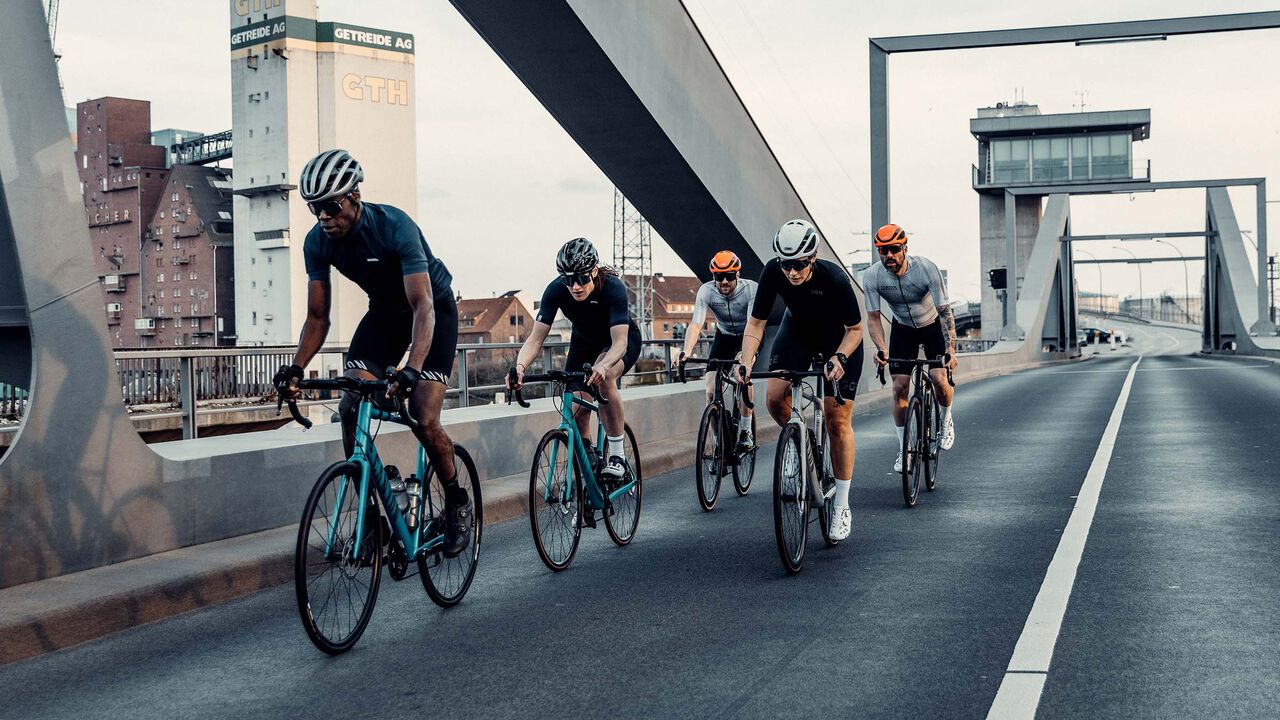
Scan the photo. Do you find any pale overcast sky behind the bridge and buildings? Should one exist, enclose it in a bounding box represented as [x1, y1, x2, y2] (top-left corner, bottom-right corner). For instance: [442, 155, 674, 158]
[58, 0, 1280, 300]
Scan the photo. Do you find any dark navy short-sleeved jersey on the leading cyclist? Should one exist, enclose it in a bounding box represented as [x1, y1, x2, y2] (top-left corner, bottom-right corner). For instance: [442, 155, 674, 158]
[302, 202, 453, 311]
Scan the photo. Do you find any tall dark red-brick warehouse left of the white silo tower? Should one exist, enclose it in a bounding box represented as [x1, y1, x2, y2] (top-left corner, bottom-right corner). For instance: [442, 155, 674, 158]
[76, 97, 236, 347]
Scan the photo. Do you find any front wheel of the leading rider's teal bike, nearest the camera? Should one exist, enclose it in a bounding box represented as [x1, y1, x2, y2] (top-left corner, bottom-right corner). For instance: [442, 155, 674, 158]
[293, 462, 384, 655]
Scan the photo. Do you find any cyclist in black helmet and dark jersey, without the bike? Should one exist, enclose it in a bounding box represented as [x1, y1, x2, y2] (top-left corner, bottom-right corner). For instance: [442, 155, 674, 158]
[506, 237, 640, 479]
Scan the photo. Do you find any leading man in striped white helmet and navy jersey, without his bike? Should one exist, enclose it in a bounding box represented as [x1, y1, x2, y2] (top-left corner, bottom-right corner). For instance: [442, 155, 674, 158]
[275, 150, 471, 557]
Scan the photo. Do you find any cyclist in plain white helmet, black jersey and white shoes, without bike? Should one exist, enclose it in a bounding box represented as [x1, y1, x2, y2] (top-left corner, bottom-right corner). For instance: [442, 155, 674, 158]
[742, 220, 863, 539]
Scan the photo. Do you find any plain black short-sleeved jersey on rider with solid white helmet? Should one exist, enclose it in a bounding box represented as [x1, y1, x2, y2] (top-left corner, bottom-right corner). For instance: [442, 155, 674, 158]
[751, 258, 863, 336]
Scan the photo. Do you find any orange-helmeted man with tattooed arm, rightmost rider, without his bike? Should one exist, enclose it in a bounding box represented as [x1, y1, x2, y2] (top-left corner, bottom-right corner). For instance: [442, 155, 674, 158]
[863, 224, 956, 473]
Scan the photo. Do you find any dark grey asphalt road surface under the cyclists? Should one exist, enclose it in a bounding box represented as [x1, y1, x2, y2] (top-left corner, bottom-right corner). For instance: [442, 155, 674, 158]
[0, 333, 1280, 719]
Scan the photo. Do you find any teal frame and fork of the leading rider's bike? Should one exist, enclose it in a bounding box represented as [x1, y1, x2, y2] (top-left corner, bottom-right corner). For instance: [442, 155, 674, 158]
[325, 397, 444, 560]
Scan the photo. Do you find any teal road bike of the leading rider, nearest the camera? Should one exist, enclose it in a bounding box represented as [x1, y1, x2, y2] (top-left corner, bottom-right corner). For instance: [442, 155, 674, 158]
[278, 368, 484, 655]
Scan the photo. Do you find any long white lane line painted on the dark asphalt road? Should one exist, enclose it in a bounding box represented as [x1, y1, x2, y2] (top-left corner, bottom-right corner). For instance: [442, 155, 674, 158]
[987, 356, 1142, 720]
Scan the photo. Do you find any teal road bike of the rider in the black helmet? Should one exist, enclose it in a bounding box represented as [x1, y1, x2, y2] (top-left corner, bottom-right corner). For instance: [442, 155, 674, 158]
[508, 368, 644, 571]
